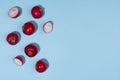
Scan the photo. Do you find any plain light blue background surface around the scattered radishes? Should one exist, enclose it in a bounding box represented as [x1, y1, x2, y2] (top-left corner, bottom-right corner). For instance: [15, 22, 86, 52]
[0, 0, 120, 80]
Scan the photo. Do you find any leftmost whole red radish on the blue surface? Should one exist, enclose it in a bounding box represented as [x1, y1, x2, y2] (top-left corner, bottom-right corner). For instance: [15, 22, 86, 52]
[7, 32, 19, 45]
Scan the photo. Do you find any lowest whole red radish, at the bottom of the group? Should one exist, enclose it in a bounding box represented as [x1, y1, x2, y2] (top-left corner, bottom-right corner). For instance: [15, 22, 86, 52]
[35, 60, 48, 73]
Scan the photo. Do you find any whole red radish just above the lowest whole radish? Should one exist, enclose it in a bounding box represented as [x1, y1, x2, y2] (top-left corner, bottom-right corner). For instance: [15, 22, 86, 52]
[24, 44, 38, 57]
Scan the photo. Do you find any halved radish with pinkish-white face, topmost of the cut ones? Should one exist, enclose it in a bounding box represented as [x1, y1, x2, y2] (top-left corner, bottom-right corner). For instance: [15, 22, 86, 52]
[8, 7, 20, 18]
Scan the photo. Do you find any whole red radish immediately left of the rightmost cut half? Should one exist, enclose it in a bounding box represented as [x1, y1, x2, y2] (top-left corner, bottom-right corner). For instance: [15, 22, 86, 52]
[22, 22, 35, 35]
